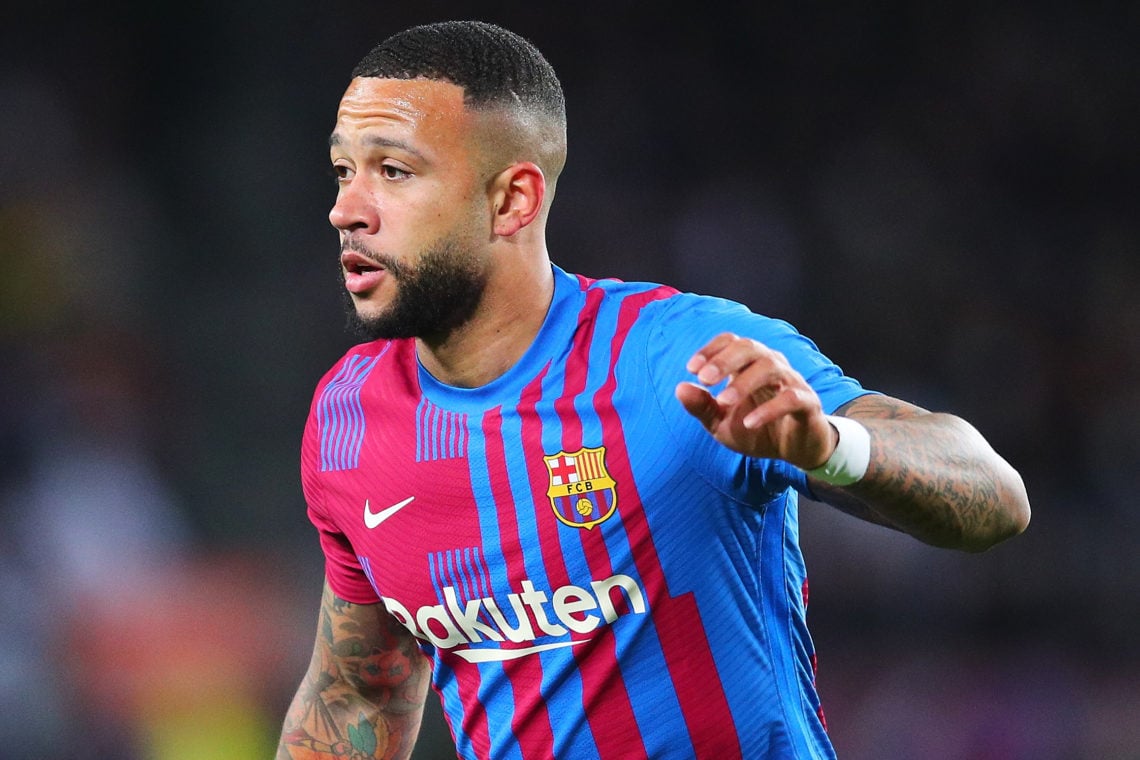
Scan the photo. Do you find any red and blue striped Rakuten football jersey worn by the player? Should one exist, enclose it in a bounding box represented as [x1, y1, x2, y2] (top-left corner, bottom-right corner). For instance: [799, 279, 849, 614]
[302, 267, 868, 760]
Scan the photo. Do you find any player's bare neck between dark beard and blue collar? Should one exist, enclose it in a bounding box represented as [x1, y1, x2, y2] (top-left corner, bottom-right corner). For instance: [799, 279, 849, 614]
[416, 256, 554, 387]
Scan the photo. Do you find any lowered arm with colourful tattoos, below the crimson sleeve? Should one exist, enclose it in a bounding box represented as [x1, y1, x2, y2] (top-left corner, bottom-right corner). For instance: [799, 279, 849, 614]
[277, 583, 430, 760]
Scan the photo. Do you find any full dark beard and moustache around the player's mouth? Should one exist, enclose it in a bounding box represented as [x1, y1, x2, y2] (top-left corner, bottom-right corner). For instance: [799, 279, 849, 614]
[341, 233, 487, 341]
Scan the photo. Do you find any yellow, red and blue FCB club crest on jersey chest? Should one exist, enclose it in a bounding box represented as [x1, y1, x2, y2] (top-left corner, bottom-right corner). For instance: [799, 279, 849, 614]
[543, 447, 618, 530]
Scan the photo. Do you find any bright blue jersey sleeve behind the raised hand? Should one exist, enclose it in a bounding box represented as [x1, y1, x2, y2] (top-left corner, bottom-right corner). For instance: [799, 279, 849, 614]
[646, 293, 874, 506]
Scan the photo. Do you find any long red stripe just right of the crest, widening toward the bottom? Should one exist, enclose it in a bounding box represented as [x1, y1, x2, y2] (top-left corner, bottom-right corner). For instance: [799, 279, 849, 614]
[594, 287, 741, 760]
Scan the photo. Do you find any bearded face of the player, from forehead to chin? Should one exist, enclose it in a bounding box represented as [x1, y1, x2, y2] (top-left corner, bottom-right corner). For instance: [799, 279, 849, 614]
[328, 77, 490, 338]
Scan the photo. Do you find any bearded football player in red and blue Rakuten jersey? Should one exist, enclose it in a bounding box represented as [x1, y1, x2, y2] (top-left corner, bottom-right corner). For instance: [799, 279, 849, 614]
[278, 22, 1029, 760]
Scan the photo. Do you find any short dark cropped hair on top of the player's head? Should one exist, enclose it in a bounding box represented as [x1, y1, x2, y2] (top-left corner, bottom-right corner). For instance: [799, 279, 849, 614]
[352, 21, 565, 125]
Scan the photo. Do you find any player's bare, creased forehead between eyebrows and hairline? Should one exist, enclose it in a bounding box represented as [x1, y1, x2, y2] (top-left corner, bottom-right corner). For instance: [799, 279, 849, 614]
[333, 76, 472, 147]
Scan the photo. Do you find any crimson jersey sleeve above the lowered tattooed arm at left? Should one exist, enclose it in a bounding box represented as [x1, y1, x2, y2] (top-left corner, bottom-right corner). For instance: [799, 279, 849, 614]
[301, 391, 380, 604]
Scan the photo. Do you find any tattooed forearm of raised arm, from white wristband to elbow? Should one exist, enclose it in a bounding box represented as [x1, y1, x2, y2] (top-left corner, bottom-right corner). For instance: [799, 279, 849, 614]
[812, 395, 1028, 550]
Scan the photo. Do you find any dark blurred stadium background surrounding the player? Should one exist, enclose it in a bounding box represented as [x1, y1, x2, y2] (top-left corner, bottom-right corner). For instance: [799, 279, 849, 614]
[0, 0, 1140, 760]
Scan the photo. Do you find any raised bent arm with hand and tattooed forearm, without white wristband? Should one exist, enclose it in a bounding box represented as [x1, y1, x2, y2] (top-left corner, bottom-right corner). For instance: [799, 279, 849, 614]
[677, 334, 1029, 551]
